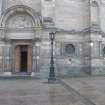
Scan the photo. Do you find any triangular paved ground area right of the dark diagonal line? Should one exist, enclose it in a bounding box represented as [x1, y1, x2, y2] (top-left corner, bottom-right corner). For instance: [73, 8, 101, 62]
[62, 77, 105, 105]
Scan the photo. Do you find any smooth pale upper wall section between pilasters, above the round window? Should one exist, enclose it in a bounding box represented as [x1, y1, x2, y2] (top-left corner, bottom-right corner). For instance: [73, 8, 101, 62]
[55, 0, 90, 30]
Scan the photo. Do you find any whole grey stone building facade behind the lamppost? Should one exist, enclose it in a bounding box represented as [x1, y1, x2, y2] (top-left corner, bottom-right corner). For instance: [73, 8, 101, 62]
[0, 0, 105, 77]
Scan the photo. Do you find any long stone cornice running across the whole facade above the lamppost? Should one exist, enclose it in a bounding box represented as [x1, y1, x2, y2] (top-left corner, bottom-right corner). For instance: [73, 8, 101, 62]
[0, 27, 105, 36]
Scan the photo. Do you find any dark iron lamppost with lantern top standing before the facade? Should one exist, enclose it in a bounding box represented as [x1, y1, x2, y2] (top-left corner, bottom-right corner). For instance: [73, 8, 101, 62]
[48, 32, 56, 83]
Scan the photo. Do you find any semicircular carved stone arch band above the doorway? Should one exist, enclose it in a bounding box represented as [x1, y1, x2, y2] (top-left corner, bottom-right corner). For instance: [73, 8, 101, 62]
[0, 5, 41, 27]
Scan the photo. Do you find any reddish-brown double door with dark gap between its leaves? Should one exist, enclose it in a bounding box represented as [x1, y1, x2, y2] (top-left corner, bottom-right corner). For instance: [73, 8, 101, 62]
[14, 45, 32, 73]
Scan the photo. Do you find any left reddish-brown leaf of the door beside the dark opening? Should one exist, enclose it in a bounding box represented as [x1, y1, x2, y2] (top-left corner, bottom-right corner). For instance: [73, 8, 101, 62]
[15, 46, 21, 72]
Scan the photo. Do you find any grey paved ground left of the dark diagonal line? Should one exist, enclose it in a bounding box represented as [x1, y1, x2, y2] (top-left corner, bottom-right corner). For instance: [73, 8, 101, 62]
[0, 79, 94, 105]
